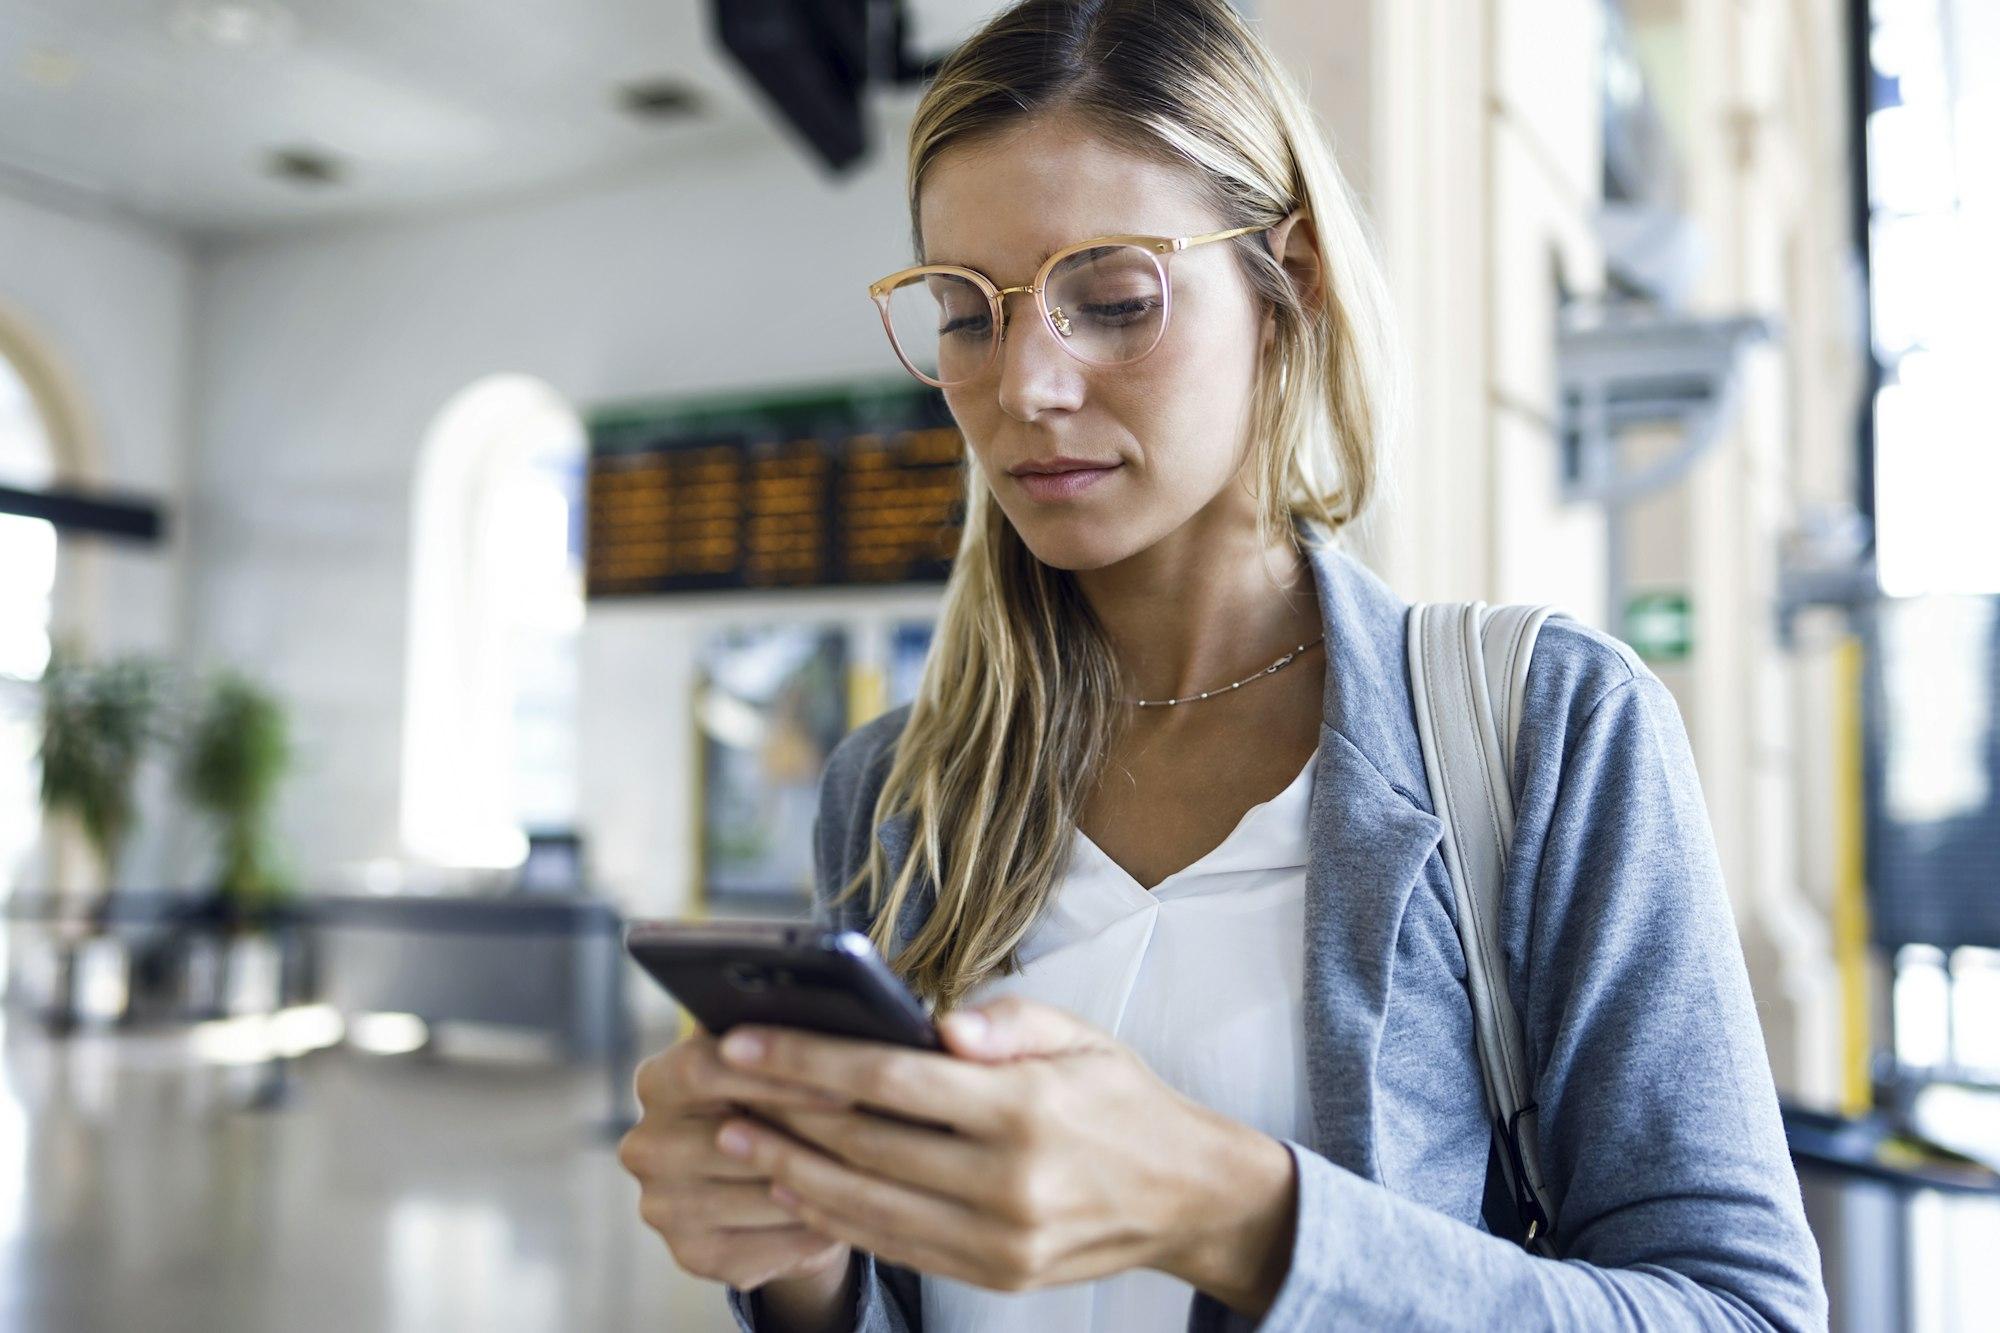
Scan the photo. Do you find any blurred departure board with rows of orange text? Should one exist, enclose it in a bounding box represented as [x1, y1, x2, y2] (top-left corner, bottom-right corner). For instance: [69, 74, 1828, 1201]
[584, 380, 964, 596]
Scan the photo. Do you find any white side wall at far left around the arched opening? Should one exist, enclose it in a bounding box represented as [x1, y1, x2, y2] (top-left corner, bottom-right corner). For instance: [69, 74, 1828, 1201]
[0, 176, 194, 885]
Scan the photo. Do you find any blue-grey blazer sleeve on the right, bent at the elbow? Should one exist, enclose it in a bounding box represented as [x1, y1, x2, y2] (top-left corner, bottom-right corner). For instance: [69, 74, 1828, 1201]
[1188, 671, 1826, 1333]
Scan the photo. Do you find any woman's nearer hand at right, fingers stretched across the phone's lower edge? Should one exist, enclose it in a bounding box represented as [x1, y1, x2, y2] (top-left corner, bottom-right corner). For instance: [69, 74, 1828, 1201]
[704, 997, 1296, 1311]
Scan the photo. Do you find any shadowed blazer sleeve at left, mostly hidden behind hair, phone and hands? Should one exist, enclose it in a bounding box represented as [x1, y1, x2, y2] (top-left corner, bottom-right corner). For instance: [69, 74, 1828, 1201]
[724, 707, 924, 1333]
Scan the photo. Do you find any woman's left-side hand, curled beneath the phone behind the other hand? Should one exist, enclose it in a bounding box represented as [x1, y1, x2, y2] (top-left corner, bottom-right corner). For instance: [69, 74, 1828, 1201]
[618, 1025, 848, 1291]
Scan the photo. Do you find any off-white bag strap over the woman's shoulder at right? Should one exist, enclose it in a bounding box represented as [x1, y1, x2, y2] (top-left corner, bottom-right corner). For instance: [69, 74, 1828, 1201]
[1410, 602, 1562, 1253]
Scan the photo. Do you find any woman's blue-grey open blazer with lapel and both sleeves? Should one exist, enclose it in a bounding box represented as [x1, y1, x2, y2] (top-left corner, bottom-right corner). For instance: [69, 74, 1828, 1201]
[728, 524, 1826, 1333]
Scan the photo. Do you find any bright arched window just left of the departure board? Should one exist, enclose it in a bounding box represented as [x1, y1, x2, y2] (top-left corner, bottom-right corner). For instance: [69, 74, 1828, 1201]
[402, 376, 584, 867]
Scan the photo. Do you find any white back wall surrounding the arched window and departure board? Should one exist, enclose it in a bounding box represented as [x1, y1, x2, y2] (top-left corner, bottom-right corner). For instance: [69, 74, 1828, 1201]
[192, 126, 936, 928]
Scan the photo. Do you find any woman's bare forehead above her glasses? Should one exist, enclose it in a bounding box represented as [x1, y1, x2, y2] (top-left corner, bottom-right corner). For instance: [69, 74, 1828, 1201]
[918, 120, 1222, 282]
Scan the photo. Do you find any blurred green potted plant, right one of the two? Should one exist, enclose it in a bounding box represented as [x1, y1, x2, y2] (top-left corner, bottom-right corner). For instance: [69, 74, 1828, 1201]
[178, 673, 292, 1011]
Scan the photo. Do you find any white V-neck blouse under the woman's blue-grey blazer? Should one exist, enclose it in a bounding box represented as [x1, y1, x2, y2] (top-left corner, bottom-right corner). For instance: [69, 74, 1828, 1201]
[920, 753, 1318, 1333]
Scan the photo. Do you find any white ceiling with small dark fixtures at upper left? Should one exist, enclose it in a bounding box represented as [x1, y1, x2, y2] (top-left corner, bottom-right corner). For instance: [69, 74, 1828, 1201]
[0, 0, 996, 236]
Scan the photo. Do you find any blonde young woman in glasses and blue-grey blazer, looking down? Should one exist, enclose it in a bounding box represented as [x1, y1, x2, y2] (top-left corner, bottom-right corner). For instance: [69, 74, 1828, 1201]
[620, 0, 1826, 1333]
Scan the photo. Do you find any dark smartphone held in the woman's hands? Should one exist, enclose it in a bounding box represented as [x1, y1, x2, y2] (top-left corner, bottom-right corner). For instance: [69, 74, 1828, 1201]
[624, 921, 944, 1051]
